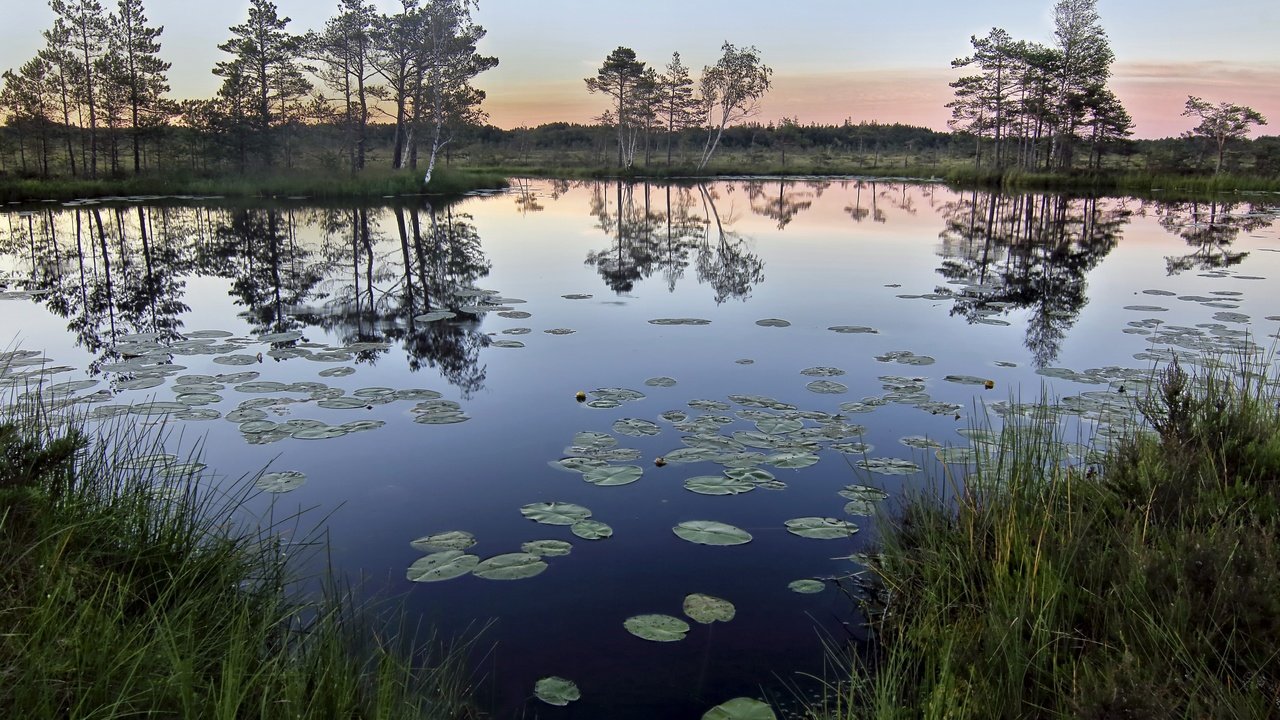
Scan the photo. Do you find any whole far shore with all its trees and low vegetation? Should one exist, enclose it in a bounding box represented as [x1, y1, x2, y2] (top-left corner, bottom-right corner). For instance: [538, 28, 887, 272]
[0, 0, 1280, 186]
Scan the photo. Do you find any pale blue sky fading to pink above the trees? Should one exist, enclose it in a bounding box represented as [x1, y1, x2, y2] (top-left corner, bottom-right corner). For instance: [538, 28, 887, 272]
[0, 0, 1280, 137]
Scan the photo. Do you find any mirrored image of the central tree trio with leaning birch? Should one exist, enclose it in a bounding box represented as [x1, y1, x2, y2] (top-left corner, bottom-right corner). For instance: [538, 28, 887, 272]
[586, 182, 764, 302]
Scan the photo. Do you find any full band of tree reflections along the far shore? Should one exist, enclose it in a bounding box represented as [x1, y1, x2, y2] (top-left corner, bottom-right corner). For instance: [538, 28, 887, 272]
[3, 184, 1274, 386]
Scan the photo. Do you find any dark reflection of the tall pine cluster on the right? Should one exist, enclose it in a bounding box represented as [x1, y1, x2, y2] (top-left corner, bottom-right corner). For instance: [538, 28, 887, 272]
[938, 191, 1130, 368]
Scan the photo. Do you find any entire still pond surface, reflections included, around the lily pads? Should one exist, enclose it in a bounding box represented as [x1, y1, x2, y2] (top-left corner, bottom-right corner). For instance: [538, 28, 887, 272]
[0, 181, 1280, 717]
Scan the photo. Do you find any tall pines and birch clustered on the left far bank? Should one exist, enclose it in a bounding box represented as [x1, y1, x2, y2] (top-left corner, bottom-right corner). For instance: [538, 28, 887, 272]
[0, 0, 498, 179]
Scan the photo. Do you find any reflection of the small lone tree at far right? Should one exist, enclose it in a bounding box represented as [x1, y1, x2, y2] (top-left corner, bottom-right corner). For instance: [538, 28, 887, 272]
[1155, 200, 1275, 275]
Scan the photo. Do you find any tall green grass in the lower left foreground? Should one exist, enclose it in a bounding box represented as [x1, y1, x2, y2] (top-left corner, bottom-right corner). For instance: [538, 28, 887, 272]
[0, 384, 472, 720]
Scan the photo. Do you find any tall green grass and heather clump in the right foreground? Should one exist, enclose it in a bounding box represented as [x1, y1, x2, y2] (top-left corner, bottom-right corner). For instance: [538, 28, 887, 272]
[810, 356, 1280, 720]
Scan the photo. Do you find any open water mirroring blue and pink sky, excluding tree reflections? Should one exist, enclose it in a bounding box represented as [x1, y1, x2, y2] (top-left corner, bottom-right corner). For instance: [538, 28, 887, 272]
[0, 181, 1280, 717]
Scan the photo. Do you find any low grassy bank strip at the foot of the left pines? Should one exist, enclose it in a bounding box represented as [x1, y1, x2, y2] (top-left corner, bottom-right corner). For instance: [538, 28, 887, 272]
[0, 168, 507, 202]
